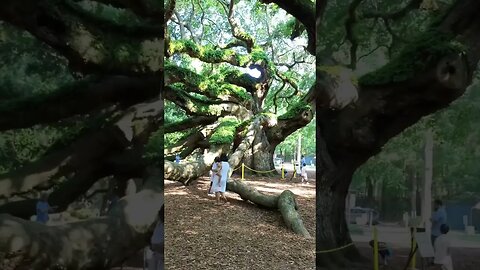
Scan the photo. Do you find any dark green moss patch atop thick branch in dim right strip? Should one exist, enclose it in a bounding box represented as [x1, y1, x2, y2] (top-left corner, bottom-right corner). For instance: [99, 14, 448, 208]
[358, 30, 465, 86]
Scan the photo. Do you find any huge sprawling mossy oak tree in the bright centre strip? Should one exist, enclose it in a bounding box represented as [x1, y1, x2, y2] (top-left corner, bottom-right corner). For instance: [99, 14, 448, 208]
[164, 1, 315, 237]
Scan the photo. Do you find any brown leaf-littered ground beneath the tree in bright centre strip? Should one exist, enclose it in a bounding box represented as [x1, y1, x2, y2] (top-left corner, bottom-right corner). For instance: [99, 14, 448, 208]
[165, 176, 315, 270]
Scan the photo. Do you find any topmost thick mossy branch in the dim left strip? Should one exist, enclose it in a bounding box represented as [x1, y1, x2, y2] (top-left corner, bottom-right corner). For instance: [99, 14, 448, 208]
[0, 0, 163, 74]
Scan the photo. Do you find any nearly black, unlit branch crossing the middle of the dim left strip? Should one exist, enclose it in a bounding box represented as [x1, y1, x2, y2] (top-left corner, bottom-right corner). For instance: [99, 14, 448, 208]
[0, 76, 160, 131]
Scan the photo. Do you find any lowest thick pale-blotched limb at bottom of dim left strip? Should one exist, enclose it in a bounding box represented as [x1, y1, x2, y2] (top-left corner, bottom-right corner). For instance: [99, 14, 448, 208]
[0, 168, 163, 270]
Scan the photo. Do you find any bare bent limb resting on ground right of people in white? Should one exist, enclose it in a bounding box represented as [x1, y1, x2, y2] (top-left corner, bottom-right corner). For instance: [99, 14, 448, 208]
[227, 180, 311, 238]
